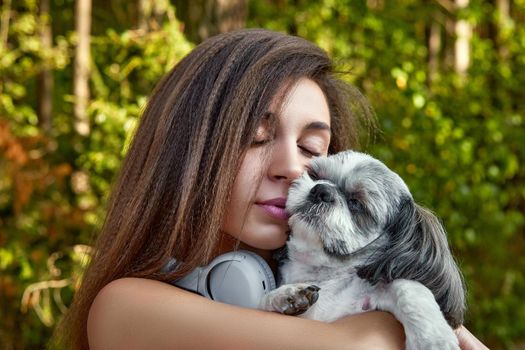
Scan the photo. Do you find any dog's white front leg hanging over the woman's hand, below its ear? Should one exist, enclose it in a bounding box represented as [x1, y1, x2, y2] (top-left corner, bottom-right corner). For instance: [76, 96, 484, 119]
[372, 279, 459, 350]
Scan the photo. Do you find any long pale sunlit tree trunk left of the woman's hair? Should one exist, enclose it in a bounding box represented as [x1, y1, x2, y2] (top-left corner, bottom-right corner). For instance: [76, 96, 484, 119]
[73, 0, 91, 136]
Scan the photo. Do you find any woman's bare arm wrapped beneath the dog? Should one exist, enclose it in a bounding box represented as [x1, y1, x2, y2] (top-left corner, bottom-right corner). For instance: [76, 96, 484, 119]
[88, 278, 404, 350]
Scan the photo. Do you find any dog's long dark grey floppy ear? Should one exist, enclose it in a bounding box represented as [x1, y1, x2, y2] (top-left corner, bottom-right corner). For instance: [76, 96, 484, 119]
[357, 196, 465, 328]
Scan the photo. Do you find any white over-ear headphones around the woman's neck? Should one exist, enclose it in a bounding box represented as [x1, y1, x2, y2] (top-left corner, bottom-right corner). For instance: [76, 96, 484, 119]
[164, 250, 275, 308]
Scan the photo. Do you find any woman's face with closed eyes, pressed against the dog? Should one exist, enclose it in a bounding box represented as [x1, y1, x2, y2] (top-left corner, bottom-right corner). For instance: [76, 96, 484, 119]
[222, 78, 330, 250]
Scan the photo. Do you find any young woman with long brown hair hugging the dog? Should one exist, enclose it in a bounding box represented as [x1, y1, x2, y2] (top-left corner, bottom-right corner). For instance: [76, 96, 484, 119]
[55, 30, 488, 350]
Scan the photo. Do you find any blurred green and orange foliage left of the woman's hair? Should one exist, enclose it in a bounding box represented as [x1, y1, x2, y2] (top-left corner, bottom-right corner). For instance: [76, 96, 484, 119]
[0, 1, 192, 349]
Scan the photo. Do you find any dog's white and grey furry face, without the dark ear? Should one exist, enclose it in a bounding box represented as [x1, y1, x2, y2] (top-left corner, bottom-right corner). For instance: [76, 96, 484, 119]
[286, 151, 411, 263]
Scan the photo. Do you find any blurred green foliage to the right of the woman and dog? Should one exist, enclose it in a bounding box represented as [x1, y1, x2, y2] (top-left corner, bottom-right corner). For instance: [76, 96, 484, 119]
[250, 0, 525, 348]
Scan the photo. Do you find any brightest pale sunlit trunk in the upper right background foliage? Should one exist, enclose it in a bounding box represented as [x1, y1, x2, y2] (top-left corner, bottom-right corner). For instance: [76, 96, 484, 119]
[454, 0, 472, 77]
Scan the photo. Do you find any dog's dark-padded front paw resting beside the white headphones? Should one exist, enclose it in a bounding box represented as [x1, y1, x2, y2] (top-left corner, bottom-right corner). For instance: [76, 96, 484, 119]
[264, 283, 320, 316]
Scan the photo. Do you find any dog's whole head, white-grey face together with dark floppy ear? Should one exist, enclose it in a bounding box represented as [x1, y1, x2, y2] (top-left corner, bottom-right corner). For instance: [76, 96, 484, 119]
[286, 151, 464, 327]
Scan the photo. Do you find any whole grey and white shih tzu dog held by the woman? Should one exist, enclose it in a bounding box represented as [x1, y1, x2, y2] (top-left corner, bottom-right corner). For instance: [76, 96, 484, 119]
[261, 151, 465, 349]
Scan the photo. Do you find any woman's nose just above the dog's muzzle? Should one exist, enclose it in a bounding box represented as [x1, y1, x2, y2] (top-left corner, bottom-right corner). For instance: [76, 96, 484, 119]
[268, 142, 306, 182]
